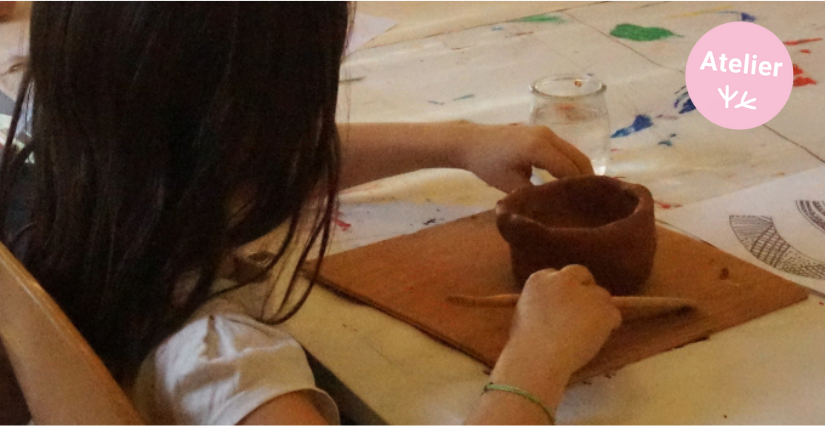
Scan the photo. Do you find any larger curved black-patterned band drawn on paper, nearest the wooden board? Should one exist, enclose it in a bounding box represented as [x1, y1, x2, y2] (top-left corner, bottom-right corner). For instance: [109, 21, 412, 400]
[730, 215, 825, 280]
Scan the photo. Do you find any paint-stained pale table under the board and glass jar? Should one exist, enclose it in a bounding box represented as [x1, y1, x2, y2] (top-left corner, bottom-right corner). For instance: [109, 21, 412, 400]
[276, 2, 825, 424]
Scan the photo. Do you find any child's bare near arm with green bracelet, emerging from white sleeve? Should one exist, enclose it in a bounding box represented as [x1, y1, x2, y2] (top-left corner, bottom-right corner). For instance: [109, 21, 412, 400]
[235, 265, 621, 424]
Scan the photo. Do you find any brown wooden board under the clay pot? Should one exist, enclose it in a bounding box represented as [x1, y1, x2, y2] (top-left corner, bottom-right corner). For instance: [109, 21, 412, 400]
[308, 212, 808, 381]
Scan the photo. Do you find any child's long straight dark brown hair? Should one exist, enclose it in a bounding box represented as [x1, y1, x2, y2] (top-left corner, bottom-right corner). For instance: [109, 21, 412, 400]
[0, 2, 349, 381]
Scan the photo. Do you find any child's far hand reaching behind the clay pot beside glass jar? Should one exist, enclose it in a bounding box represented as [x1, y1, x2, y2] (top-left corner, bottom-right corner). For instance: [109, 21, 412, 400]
[455, 122, 593, 193]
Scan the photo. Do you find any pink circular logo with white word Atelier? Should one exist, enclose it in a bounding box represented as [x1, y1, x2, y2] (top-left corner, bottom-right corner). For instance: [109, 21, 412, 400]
[685, 22, 793, 129]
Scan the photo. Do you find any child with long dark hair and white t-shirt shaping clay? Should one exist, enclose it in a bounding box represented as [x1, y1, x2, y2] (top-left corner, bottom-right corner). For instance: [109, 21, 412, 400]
[0, 2, 620, 423]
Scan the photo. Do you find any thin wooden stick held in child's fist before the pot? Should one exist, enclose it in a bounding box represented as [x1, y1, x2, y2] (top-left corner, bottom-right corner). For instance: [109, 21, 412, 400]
[447, 293, 697, 321]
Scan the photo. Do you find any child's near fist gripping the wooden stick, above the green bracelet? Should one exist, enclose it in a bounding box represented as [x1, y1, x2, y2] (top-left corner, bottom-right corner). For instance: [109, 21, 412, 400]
[490, 265, 621, 407]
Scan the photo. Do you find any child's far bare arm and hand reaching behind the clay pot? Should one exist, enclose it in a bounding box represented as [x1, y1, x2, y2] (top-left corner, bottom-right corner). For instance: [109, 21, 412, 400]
[338, 121, 593, 192]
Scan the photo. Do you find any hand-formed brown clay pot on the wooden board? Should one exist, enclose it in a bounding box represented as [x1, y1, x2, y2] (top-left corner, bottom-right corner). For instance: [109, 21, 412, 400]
[496, 176, 656, 295]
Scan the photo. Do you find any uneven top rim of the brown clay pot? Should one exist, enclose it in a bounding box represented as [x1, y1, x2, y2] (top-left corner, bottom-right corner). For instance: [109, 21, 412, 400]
[496, 176, 653, 234]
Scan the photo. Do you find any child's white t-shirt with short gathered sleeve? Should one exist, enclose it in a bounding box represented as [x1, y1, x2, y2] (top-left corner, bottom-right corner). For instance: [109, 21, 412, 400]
[131, 283, 340, 424]
